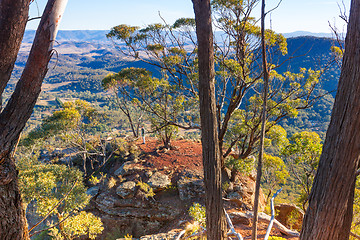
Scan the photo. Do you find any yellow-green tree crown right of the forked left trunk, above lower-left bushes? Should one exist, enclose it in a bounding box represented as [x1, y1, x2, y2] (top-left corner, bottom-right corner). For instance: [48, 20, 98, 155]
[20, 100, 112, 175]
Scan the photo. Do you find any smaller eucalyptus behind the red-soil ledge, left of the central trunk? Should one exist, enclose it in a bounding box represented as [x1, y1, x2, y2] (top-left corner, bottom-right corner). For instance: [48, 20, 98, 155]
[102, 68, 191, 148]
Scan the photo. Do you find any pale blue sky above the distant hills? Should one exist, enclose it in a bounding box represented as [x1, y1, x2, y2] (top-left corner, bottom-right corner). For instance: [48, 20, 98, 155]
[28, 0, 350, 33]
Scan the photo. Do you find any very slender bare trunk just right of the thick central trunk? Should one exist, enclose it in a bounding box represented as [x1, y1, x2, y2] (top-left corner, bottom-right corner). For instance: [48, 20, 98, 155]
[251, 0, 269, 240]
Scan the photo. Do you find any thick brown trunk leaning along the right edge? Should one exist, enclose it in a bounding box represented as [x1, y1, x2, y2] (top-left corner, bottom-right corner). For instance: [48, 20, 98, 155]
[300, 0, 360, 240]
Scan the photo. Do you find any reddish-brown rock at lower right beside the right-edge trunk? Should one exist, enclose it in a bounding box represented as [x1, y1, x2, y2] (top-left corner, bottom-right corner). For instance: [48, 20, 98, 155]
[275, 203, 304, 231]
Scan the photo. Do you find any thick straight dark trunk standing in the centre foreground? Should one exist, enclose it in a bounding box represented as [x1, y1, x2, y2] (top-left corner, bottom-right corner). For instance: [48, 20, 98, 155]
[192, 0, 226, 240]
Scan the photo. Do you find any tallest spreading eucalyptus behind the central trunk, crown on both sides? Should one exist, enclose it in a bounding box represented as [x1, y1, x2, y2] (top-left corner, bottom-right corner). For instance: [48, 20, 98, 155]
[107, 0, 321, 169]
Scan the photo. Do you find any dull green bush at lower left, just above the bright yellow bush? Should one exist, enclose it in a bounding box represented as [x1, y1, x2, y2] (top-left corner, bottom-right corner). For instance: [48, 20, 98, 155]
[19, 163, 89, 216]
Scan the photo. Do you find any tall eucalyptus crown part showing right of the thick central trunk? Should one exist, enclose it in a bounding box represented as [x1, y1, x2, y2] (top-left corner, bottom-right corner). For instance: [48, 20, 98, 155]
[212, 0, 320, 165]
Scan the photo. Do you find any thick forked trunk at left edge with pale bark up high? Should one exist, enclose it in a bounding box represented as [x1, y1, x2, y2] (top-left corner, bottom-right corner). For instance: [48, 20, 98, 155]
[0, 0, 67, 237]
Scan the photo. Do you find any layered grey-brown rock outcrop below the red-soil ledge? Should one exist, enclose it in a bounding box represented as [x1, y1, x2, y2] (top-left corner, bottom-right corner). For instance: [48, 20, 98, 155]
[87, 140, 264, 240]
